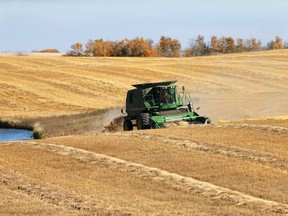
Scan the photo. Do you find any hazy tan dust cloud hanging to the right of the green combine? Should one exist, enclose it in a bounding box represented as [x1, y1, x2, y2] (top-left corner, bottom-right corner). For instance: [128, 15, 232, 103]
[183, 85, 288, 123]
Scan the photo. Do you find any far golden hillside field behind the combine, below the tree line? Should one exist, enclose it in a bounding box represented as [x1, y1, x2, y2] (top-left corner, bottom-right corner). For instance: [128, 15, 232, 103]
[0, 50, 288, 122]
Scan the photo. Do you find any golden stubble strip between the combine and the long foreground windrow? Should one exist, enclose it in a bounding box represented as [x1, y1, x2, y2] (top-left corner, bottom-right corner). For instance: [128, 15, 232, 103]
[48, 121, 288, 206]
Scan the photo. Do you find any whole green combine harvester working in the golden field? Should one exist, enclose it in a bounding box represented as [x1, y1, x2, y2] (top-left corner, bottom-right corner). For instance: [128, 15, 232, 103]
[123, 80, 211, 131]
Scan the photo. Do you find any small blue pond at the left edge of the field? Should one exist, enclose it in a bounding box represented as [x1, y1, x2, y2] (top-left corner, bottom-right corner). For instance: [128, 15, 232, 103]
[0, 129, 33, 142]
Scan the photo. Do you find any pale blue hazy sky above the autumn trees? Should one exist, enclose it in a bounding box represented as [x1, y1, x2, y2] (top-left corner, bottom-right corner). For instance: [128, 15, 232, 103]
[0, 0, 288, 52]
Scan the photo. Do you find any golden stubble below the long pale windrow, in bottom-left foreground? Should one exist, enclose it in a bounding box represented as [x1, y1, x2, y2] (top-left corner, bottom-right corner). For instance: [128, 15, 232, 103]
[0, 143, 270, 215]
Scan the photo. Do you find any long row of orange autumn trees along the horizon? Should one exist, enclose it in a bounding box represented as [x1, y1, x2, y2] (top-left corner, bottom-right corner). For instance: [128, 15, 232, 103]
[66, 35, 288, 57]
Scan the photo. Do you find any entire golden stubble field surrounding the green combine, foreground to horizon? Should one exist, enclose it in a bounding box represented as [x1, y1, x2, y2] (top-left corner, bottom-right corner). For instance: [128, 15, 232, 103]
[0, 50, 288, 215]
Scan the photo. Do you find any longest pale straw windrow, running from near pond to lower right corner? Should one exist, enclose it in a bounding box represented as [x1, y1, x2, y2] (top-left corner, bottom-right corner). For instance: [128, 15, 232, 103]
[2, 142, 288, 214]
